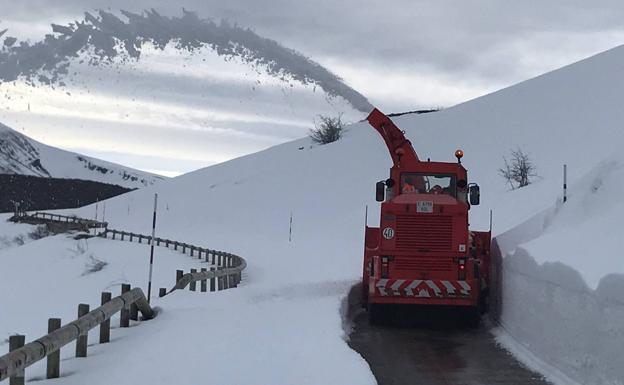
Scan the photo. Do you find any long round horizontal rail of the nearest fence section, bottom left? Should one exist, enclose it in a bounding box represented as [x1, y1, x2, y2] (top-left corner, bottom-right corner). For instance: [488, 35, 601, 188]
[0, 288, 154, 381]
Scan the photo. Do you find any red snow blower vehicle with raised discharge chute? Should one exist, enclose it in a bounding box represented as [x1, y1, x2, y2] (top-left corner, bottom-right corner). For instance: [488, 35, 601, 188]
[362, 109, 490, 307]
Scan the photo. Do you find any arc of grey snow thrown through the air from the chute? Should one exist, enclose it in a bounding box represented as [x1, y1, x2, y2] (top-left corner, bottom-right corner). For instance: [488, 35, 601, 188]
[0, 9, 372, 112]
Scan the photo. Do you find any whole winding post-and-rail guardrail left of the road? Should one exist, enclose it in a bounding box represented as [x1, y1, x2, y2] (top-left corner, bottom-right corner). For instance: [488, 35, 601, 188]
[0, 212, 247, 384]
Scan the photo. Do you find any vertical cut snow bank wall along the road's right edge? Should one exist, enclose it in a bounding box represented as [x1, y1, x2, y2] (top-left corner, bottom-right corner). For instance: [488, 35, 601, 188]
[492, 208, 624, 385]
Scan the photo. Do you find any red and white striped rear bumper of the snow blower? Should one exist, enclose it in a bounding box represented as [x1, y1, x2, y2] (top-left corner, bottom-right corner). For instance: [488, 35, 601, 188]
[368, 278, 471, 298]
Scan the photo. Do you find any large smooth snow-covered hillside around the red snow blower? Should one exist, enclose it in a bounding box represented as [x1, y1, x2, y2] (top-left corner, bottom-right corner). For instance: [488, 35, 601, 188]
[0, 47, 624, 384]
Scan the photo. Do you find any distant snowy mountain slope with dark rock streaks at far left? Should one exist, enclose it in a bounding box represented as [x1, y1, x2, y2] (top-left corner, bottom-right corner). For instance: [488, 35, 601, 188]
[0, 123, 164, 188]
